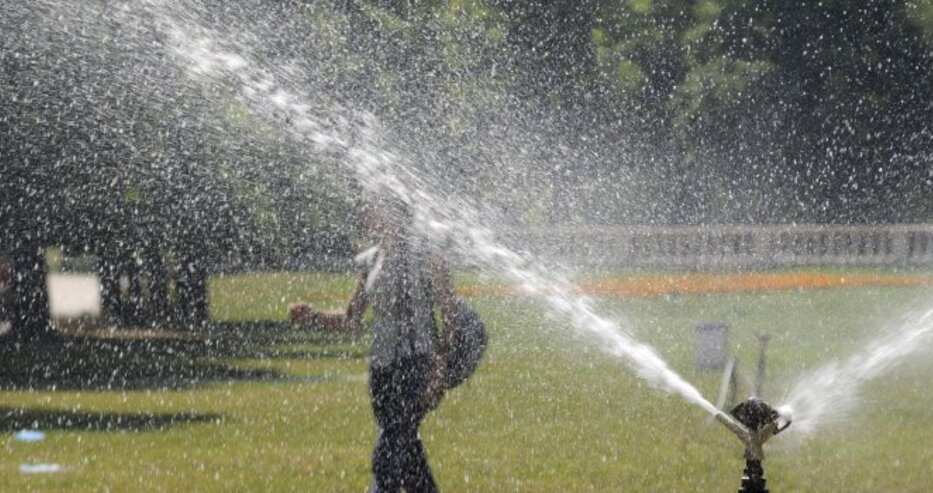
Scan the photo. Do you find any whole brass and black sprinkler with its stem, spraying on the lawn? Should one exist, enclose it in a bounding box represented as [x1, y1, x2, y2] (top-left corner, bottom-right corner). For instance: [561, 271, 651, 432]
[716, 397, 791, 493]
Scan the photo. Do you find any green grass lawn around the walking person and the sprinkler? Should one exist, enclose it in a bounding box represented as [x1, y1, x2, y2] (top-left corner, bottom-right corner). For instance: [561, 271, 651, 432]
[0, 274, 933, 492]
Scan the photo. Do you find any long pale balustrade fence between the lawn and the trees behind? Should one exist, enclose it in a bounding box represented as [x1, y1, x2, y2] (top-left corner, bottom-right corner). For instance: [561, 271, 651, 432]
[514, 224, 933, 269]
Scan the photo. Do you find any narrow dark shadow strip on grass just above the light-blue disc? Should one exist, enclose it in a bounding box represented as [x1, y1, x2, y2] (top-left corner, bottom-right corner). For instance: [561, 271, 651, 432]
[0, 407, 223, 433]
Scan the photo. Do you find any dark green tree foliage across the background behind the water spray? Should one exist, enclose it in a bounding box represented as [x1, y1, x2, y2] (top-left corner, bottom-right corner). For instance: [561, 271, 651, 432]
[0, 0, 933, 263]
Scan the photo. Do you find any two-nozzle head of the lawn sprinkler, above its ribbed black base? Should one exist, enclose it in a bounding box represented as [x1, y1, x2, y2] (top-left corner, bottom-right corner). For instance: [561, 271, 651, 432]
[716, 397, 791, 461]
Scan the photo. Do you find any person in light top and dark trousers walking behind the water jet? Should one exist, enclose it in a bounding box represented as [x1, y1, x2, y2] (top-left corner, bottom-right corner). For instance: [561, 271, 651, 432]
[290, 194, 456, 493]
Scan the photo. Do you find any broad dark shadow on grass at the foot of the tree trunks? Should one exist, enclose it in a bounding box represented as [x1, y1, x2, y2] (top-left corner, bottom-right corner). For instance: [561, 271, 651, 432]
[0, 323, 365, 390]
